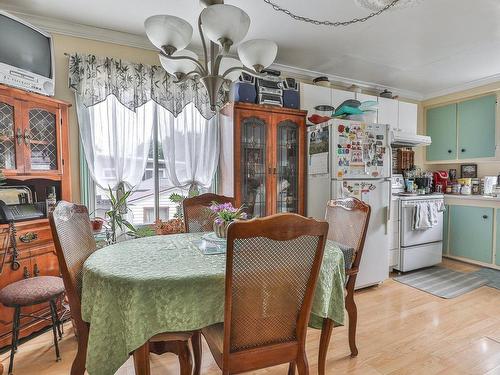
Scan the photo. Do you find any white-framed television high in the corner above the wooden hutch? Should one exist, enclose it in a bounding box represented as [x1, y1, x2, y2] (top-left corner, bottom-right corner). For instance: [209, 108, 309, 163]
[0, 10, 55, 96]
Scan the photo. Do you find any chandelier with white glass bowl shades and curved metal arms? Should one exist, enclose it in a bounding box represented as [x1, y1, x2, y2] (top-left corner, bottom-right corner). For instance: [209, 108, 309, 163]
[144, 0, 278, 111]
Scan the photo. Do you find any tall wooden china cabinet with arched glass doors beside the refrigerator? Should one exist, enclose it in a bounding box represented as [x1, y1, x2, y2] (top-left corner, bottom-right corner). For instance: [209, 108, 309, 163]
[219, 103, 306, 217]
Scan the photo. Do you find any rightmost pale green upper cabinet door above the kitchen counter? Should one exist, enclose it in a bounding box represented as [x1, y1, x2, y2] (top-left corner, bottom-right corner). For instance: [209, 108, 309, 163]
[457, 95, 497, 159]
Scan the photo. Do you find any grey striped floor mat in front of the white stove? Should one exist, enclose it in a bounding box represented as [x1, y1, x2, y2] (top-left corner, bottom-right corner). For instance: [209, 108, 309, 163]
[394, 267, 488, 298]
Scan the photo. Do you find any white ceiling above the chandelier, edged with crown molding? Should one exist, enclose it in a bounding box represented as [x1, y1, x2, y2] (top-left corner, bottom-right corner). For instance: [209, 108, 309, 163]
[0, 0, 500, 99]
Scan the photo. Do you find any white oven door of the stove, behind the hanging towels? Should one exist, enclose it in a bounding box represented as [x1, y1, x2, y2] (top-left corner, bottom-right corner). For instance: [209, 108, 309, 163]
[400, 200, 443, 247]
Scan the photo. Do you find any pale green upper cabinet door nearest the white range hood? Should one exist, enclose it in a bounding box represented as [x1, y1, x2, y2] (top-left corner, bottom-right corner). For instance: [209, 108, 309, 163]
[426, 104, 457, 161]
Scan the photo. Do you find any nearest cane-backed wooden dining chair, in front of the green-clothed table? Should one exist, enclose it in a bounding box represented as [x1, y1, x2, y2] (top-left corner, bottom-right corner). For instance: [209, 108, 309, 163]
[202, 214, 328, 375]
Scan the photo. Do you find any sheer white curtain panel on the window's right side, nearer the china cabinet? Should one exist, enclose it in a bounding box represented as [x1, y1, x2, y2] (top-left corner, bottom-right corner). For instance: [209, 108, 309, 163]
[158, 103, 219, 189]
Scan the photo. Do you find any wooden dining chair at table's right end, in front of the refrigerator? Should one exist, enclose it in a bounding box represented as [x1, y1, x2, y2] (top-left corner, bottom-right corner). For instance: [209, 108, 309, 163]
[318, 198, 371, 375]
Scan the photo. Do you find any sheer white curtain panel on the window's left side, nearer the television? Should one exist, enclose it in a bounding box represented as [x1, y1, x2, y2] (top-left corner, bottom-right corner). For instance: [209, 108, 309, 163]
[76, 94, 154, 190]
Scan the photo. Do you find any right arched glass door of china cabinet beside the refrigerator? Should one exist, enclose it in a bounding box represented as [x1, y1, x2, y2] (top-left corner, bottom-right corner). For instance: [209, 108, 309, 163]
[275, 120, 299, 213]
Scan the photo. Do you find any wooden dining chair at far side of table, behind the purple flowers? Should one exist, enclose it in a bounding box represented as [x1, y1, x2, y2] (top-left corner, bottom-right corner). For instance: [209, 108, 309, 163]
[182, 193, 234, 233]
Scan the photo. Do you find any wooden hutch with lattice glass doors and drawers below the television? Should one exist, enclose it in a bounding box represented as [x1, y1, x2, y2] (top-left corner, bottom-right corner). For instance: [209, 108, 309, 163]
[0, 85, 71, 347]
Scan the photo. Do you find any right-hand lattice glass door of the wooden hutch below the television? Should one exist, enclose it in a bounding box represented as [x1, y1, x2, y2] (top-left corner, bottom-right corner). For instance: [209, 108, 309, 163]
[24, 107, 60, 172]
